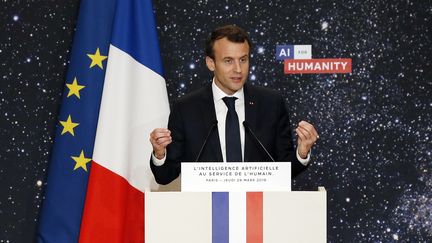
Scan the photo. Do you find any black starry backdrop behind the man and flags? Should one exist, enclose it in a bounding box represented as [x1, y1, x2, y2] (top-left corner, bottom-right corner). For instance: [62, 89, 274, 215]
[0, 0, 432, 242]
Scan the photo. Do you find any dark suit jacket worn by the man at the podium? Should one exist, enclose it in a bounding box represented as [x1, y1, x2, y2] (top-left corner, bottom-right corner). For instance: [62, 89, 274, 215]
[150, 84, 306, 184]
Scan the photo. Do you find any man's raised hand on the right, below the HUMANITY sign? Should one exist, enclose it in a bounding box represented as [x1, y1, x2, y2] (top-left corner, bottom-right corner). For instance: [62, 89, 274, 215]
[296, 121, 319, 159]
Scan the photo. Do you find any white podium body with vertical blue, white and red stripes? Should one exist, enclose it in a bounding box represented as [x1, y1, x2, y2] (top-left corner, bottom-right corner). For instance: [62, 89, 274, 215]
[144, 187, 327, 243]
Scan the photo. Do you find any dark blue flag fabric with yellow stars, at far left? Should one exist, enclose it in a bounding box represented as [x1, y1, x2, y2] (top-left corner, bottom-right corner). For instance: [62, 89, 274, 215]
[37, 0, 116, 243]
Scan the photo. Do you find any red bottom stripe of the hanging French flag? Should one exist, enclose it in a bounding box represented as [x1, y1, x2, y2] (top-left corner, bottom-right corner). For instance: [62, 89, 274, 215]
[79, 161, 144, 243]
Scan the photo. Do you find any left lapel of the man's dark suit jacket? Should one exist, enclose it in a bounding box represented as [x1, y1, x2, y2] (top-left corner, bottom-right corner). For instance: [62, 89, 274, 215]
[200, 85, 223, 161]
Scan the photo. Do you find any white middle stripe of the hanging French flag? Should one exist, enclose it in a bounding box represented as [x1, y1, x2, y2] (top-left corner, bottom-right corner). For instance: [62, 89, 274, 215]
[93, 45, 169, 191]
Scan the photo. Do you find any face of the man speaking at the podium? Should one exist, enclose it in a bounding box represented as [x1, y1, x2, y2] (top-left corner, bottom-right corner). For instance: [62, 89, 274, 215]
[206, 38, 249, 95]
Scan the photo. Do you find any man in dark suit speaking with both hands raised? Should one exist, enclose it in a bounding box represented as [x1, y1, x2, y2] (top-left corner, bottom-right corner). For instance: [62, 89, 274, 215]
[150, 25, 318, 184]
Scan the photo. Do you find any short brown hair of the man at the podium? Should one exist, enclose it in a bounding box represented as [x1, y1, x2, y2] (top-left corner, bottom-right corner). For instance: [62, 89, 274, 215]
[205, 25, 252, 59]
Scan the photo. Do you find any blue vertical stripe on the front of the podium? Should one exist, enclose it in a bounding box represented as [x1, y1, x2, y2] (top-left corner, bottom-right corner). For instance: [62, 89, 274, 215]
[212, 192, 229, 243]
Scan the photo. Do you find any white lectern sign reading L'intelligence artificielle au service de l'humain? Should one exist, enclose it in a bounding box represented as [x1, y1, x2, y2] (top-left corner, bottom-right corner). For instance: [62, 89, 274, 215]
[181, 162, 291, 192]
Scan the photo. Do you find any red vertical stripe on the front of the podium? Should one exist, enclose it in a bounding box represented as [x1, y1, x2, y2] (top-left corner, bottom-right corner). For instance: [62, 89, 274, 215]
[246, 192, 263, 243]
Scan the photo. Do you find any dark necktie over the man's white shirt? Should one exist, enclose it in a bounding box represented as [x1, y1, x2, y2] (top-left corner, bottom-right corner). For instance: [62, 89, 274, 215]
[223, 97, 242, 162]
